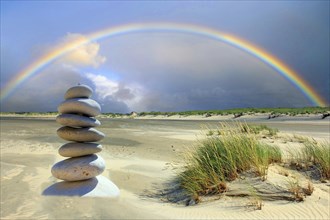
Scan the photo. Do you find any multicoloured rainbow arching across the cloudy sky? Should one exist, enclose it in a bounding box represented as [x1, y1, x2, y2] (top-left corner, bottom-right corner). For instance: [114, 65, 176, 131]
[0, 22, 327, 106]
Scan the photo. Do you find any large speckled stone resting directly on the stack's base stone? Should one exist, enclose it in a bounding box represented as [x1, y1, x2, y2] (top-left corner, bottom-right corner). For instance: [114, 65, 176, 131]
[52, 154, 105, 181]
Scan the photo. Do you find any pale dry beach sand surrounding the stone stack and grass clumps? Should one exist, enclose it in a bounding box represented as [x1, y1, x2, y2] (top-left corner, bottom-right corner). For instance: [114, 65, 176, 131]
[0, 117, 330, 219]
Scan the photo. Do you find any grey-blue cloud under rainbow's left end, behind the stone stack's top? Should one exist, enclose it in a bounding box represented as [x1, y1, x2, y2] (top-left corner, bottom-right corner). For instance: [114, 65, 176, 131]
[1, 65, 132, 113]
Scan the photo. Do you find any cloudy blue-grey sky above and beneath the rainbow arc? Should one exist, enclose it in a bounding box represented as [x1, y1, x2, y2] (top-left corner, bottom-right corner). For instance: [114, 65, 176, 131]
[0, 0, 330, 113]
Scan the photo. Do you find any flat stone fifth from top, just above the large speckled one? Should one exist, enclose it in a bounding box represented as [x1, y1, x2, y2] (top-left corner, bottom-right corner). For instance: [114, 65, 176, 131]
[58, 142, 102, 157]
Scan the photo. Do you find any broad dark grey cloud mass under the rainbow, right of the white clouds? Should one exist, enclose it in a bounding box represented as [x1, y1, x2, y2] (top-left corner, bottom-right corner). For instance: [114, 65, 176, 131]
[98, 34, 309, 111]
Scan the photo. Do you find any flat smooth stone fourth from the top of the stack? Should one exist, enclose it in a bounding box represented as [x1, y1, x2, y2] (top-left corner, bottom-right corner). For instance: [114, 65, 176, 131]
[57, 126, 105, 142]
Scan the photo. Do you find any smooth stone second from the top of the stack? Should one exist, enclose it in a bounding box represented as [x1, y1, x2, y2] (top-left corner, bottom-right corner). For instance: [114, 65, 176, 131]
[57, 98, 101, 117]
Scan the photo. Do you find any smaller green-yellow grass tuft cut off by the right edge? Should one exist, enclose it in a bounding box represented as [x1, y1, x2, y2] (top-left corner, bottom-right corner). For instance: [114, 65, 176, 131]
[291, 138, 330, 179]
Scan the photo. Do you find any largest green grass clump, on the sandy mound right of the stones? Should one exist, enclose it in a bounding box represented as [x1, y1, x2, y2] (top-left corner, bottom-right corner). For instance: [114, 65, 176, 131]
[179, 124, 282, 201]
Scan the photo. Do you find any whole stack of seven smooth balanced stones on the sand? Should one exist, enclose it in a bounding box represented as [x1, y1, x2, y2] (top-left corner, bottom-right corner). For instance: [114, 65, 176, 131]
[43, 85, 119, 197]
